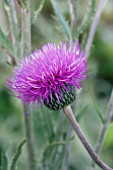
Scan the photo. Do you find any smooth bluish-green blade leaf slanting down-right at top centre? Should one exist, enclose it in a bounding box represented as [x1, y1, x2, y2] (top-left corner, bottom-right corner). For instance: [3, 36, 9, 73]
[51, 0, 71, 39]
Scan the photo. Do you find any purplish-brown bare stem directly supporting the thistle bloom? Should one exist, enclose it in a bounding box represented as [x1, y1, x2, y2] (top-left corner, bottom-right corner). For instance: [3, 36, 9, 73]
[64, 106, 113, 170]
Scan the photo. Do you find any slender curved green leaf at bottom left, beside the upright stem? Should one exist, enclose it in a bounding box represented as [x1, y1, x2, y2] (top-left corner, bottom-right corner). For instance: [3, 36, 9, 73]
[10, 139, 26, 170]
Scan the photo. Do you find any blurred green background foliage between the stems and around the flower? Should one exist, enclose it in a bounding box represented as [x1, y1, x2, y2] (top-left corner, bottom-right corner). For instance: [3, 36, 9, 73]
[0, 0, 113, 170]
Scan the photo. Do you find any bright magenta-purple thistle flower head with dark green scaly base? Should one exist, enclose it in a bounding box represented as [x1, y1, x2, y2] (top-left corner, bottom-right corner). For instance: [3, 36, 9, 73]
[7, 42, 87, 110]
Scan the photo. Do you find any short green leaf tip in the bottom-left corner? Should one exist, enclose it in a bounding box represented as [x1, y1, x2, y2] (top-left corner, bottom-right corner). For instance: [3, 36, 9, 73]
[0, 149, 8, 170]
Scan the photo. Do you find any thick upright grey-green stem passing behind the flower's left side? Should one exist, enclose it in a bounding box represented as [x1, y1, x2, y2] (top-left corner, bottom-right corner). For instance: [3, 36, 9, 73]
[21, 0, 36, 170]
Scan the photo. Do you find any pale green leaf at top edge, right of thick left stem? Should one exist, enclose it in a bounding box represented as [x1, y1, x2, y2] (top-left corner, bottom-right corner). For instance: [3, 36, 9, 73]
[31, 0, 45, 24]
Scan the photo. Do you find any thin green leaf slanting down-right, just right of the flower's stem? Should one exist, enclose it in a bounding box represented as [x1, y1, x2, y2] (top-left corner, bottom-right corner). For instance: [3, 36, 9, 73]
[87, 85, 105, 124]
